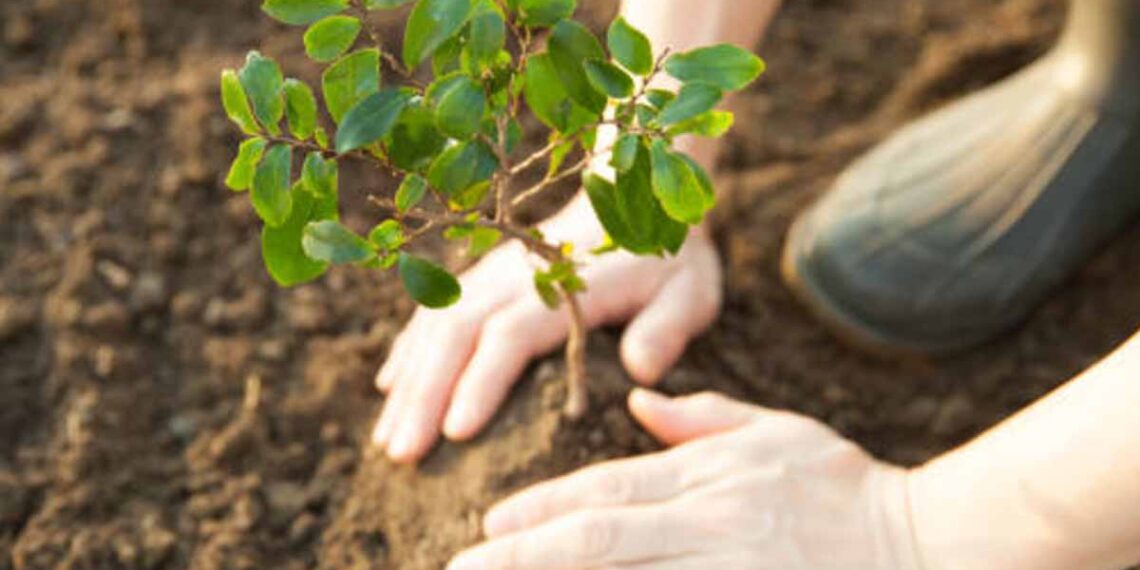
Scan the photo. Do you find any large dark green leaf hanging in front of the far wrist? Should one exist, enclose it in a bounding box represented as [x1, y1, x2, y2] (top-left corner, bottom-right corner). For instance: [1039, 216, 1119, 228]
[584, 139, 689, 255]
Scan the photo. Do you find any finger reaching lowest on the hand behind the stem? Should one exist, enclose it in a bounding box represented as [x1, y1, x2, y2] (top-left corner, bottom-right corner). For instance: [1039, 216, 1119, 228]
[388, 319, 477, 463]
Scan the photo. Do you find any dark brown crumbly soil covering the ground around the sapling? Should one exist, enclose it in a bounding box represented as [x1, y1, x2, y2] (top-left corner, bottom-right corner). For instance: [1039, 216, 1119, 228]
[0, 0, 1140, 570]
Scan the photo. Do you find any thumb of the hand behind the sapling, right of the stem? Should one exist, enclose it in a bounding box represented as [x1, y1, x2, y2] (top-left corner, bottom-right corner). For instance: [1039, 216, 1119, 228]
[621, 267, 720, 385]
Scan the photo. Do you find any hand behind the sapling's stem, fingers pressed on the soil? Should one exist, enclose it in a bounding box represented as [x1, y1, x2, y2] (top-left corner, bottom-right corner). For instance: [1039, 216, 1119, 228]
[373, 198, 720, 463]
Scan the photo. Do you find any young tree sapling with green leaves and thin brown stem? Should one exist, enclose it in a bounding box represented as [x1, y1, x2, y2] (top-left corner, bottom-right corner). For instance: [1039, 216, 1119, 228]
[221, 0, 764, 417]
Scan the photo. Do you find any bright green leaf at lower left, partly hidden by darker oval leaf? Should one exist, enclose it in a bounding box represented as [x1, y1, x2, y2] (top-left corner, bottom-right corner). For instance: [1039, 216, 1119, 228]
[261, 178, 337, 287]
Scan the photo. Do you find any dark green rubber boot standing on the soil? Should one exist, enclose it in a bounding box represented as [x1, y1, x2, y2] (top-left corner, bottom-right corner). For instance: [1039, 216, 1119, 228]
[782, 0, 1140, 352]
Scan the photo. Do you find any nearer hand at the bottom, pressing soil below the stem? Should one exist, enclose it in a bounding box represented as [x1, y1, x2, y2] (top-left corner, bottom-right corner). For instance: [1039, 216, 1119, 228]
[448, 390, 921, 570]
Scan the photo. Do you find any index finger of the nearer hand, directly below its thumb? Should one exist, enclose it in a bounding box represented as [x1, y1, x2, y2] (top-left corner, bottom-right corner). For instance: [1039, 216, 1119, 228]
[483, 446, 686, 537]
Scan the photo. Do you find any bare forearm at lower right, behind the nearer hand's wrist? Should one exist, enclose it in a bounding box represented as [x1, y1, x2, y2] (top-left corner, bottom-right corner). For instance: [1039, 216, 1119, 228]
[911, 334, 1140, 570]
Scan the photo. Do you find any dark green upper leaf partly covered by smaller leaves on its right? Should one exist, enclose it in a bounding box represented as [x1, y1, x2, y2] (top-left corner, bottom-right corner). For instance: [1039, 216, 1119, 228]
[548, 19, 606, 114]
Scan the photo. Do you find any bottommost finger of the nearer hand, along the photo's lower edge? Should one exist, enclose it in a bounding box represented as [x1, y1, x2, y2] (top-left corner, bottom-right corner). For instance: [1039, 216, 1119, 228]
[447, 505, 693, 570]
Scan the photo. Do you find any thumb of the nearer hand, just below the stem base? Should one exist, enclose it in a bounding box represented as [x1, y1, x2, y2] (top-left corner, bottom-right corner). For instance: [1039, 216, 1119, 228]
[629, 388, 759, 446]
